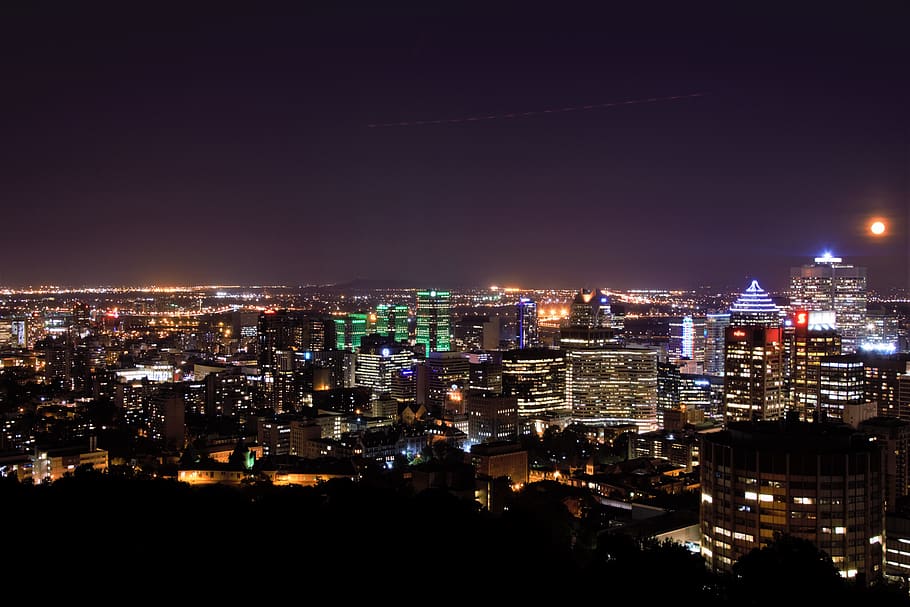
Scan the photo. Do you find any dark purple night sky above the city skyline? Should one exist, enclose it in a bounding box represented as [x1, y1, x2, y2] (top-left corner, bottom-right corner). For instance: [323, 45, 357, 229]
[0, 1, 910, 290]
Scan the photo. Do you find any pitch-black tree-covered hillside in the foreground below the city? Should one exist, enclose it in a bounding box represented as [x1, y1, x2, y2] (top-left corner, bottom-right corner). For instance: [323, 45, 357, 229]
[7, 471, 910, 606]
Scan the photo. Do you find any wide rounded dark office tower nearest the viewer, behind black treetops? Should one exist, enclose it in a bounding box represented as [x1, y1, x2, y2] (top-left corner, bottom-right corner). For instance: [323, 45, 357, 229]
[699, 421, 885, 583]
